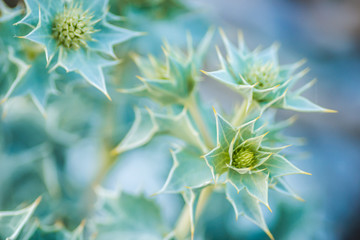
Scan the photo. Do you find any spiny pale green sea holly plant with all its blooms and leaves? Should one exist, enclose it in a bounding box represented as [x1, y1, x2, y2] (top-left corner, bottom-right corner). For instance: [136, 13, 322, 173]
[0, 0, 335, 240]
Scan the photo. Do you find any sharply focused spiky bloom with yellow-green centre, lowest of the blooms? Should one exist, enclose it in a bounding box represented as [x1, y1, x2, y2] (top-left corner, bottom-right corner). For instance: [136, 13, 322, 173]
[204, 110, 307, 238]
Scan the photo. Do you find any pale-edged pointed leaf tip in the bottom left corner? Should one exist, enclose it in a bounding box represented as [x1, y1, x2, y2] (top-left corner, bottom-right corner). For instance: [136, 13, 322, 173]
[0, 197, 41, 240]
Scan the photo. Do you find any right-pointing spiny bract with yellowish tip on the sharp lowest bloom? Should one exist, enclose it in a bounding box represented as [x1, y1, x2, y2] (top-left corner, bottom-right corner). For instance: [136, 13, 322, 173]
[262, 154, 310, 177]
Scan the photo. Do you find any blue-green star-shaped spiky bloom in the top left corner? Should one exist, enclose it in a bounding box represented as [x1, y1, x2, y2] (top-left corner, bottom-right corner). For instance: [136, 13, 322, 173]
[18, 0, 139, 95]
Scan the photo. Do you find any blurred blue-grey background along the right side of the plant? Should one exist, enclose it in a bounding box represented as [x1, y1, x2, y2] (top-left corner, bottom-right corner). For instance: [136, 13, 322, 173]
[199, 0, 360, 239]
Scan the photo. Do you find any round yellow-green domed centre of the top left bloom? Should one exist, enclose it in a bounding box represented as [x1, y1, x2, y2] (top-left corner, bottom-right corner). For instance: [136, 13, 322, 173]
[53, 7, 97, 50]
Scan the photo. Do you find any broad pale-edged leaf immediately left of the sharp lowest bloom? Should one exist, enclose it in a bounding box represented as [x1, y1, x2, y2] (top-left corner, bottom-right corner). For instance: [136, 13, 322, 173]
[159, 147, 212, 193]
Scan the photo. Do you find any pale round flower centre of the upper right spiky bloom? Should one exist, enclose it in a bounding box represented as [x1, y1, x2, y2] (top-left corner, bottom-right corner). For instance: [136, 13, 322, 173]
[244, 62, 279, 89]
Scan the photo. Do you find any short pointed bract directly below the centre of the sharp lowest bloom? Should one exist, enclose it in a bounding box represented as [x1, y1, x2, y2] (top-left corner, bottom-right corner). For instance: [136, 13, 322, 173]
[228, 170, 270, 209]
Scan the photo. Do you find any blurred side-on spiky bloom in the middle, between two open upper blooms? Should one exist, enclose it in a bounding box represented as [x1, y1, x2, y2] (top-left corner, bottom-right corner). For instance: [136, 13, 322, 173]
[119, 30, 213, 104]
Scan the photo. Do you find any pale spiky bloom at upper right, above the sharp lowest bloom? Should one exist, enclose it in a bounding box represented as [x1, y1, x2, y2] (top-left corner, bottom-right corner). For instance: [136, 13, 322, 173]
[204, 31, 333, 112]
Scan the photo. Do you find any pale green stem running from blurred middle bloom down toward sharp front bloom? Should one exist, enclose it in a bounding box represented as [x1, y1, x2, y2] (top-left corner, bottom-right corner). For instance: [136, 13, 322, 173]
[184, 94, 214, 149]
